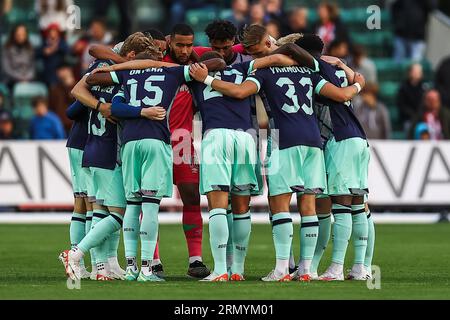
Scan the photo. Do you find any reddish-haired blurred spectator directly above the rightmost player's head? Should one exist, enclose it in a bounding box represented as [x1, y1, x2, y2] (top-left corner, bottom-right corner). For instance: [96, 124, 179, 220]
[315, 2, 350, 48]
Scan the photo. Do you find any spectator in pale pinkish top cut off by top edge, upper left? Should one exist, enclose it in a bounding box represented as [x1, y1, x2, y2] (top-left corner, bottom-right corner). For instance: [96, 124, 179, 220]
[36, 0, 73, 33]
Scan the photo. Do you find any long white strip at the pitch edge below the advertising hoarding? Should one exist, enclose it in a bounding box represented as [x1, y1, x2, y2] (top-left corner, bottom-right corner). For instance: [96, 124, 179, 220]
[0, 212, 440, 224]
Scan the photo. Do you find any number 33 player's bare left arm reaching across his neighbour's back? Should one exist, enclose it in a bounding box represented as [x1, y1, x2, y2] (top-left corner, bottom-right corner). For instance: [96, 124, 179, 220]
[190, 63, 258, 99]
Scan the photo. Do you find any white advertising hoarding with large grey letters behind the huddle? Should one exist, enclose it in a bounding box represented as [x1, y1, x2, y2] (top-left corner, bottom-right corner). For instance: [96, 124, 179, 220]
[0, 141, 450, 206]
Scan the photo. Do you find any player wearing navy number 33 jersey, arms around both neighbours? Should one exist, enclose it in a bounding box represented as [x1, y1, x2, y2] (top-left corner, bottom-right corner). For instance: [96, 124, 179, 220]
[191, 53, 364, 281]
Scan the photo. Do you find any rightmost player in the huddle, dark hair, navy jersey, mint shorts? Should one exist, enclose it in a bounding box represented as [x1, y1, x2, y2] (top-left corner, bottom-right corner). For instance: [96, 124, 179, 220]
[296, 34, 375, 281]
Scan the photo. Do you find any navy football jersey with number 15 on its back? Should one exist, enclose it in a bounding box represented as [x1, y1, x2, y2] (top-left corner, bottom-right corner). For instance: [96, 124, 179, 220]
[111, 66, 191, 144]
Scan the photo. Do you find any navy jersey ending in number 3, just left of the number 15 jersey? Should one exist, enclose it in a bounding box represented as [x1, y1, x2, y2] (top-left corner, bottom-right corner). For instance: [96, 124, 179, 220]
[83, 61, 120, 170]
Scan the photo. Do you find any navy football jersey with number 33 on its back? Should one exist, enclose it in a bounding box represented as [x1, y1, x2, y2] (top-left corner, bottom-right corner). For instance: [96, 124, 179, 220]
[247, 66, 327, 149]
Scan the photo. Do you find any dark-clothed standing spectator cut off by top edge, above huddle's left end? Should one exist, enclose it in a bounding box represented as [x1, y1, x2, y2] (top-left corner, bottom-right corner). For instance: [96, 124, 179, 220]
[95, 0, 132, 42]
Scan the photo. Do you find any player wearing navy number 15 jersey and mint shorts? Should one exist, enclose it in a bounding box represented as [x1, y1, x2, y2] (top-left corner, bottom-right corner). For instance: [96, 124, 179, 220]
[78, 46, 224, 281]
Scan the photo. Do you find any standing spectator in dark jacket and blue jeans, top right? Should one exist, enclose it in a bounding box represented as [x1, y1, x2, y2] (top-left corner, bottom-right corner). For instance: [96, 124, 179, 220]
[392, 0, 438, 62]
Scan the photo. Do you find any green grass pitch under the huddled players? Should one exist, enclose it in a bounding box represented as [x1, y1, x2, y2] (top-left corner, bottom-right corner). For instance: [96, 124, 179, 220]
[0, 224, 450, 300]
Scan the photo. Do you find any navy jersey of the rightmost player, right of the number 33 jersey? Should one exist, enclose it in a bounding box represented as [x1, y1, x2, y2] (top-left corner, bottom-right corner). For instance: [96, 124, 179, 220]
[316, 59, 366, 141]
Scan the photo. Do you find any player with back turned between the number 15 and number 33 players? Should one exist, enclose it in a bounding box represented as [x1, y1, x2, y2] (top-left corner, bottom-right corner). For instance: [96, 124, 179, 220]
[189, 52, 306, 281]
